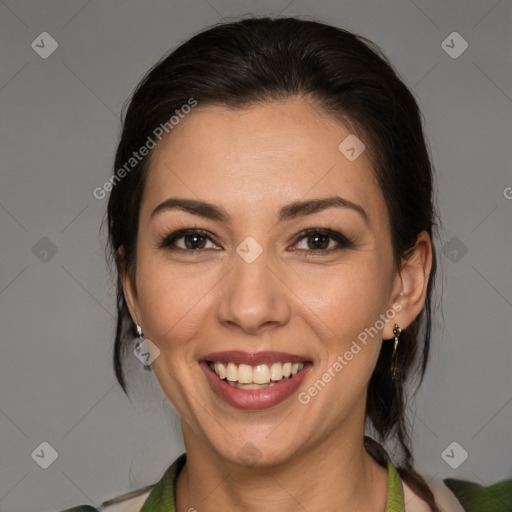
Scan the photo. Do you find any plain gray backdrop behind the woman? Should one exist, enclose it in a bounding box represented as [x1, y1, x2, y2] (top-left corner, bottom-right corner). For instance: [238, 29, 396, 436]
[0, 0, 512, 512]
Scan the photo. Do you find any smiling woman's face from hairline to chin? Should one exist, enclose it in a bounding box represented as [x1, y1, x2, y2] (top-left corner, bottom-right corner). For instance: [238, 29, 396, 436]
[124, 99, 402, 464]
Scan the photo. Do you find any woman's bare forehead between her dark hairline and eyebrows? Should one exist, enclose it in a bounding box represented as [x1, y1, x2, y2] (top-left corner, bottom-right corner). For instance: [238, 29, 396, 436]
[141, 99, 384, 222]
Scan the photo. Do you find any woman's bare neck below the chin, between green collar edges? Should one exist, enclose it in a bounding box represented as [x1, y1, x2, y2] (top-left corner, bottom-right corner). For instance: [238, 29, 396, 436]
[176, 429, 387, 512]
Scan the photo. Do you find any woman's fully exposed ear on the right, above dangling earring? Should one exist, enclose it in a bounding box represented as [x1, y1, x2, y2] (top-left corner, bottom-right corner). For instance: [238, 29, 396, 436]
[383, 231, 432, 339]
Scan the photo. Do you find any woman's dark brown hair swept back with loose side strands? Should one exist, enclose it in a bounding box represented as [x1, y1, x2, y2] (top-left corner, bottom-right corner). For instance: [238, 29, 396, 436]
[107, 18, 438, 511]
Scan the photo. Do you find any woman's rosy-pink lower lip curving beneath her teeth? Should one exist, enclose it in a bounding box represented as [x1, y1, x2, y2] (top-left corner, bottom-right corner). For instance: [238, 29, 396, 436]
[199, 361, 312, 411]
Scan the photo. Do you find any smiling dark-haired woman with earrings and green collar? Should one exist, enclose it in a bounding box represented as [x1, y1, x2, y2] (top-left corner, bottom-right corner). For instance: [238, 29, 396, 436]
[63, 18, 438, 512]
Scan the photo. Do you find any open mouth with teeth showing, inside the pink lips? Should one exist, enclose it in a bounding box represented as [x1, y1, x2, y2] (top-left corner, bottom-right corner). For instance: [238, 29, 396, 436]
[207, 361, 311, 389]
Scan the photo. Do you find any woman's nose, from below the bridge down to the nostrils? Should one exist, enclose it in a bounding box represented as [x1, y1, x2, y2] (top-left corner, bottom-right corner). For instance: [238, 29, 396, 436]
[218, 251, 290, 335]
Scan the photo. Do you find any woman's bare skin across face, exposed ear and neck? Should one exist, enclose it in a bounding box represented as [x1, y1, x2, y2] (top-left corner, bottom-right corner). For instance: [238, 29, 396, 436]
[120, 98, 432, 512]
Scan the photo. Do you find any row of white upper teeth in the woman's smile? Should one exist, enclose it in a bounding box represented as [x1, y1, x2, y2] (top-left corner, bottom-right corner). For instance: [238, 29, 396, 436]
[210, 362, 304, 384]
